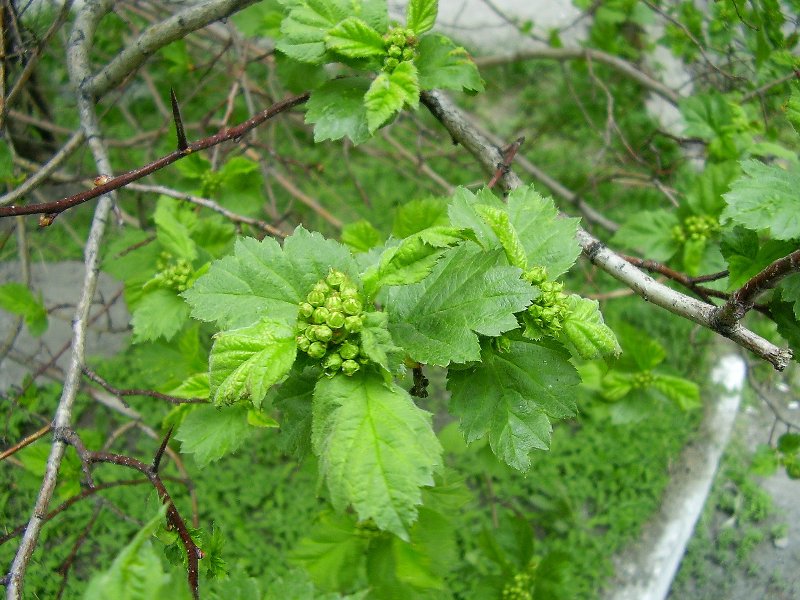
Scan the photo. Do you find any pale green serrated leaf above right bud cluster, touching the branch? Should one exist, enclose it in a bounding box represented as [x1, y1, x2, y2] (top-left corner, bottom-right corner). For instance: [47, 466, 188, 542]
[507, 186, 581, 280]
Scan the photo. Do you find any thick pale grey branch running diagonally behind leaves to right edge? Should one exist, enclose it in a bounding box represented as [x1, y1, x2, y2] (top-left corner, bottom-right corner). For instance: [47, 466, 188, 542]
[421, 91, 792, 371]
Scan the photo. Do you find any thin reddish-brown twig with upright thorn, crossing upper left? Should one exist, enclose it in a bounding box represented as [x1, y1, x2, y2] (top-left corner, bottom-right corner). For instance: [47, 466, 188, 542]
[0, 92, 309, 224]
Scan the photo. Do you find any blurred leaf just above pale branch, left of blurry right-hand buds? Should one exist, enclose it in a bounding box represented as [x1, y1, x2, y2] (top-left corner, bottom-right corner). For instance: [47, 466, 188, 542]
[611, 209, 680, 261]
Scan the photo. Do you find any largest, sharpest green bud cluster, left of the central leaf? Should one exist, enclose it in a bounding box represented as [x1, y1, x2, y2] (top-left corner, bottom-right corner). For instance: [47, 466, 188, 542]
[296, 269, 369, 375]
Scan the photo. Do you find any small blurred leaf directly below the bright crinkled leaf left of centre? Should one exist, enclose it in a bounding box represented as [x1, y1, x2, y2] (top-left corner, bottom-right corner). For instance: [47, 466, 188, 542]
[175, 405, 254, 467]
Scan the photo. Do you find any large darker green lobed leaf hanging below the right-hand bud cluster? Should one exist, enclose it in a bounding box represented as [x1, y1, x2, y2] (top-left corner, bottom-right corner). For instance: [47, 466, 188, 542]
[447, 339, 580, 471]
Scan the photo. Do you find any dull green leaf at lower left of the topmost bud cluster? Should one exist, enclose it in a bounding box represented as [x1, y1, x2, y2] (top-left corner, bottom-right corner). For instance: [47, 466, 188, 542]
[306, 77, 370, 144]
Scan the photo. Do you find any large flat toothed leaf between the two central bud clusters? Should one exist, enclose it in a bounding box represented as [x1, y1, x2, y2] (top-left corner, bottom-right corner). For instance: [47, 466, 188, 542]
[386, 243, 535, 366]
